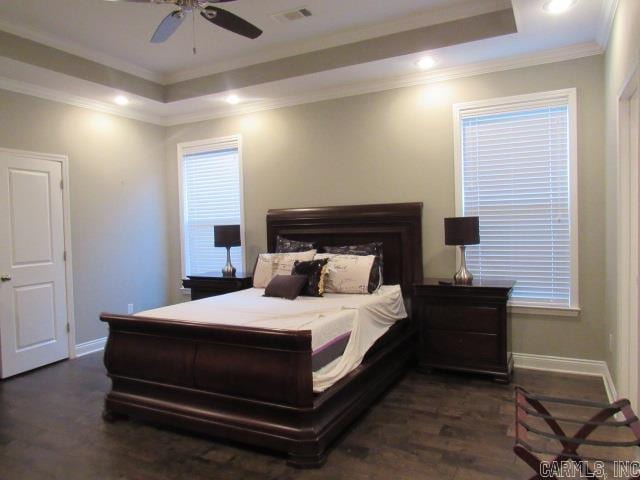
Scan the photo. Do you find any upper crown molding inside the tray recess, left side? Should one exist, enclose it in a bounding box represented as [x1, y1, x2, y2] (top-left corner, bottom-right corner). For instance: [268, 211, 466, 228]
[0, 18, 163, 83]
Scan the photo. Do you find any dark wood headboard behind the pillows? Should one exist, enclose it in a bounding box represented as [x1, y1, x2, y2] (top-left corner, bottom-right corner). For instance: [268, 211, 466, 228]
[267, 203, 422, 295]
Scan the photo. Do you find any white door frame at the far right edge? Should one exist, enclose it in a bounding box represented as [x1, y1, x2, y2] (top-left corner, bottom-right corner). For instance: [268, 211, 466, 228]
[616, 58, 640, 408]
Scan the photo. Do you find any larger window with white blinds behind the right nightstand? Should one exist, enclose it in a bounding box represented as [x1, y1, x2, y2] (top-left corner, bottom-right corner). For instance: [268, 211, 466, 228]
[454, 90, 578, 311]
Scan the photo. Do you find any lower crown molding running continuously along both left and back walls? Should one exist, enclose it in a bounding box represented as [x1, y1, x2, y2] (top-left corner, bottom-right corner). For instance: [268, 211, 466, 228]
[0, 42, 603, 126]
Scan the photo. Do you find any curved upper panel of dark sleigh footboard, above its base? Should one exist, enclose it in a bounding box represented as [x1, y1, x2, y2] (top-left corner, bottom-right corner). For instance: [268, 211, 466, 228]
[100, 314, 313, 407]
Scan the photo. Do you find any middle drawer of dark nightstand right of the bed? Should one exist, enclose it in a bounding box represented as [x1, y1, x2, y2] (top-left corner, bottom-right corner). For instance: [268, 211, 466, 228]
[425, 305, 500, 334]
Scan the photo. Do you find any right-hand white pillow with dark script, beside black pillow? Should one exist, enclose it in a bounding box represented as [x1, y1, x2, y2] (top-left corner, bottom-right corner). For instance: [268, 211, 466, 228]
[314, 253, 376, 293]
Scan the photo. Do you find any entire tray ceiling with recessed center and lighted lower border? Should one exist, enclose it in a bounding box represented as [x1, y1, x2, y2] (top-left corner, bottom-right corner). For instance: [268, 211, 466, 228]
[0, 0, 616, 124]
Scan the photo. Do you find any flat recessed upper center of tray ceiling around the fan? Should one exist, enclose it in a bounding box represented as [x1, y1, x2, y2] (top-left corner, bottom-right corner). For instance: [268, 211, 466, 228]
[0, 0, 476, 79]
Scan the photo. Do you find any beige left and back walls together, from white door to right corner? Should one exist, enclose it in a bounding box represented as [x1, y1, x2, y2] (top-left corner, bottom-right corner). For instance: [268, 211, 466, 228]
[0, 56, 610, 359]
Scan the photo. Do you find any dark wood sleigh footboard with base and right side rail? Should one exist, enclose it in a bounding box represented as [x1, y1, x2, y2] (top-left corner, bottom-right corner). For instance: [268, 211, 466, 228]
[100, 314, 415, 467]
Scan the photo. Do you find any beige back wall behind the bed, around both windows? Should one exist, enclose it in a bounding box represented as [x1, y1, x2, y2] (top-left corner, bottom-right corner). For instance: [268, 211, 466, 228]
[166, 56, 606, 359]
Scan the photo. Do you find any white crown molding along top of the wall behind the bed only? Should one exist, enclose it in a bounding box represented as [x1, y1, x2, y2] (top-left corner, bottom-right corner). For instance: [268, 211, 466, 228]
[164, 42, 603, 126]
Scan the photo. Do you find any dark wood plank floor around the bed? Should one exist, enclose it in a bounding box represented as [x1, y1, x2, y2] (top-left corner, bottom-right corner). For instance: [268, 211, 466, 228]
[0, 354, 606, 480]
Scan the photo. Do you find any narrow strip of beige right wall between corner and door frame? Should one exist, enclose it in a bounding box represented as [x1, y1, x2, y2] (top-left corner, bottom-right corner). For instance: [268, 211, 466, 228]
[605, 0, 640, 386]
